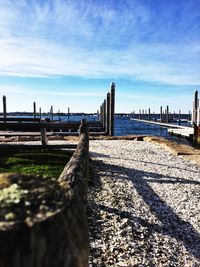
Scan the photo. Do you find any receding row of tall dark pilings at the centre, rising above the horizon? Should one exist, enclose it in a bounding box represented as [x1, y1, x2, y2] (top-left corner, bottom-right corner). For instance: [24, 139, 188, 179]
[99, 82, 115, 136]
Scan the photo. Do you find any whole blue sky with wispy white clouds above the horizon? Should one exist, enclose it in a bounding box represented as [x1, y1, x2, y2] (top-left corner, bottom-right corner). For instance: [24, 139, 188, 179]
[0, 0, 200, 113]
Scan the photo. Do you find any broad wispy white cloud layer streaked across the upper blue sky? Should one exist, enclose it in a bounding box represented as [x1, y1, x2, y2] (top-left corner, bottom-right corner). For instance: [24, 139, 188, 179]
[0, 0, 200, 85]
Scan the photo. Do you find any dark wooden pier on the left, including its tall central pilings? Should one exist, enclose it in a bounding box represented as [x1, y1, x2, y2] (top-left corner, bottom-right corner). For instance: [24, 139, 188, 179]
[0, 83, 115, 143]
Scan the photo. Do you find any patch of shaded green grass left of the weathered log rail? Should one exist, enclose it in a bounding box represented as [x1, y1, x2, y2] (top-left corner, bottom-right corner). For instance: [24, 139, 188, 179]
[0, 149, 72, 177]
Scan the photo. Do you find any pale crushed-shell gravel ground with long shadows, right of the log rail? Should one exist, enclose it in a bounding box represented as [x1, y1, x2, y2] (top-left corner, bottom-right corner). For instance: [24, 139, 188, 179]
[88, 140, 200, 267]
